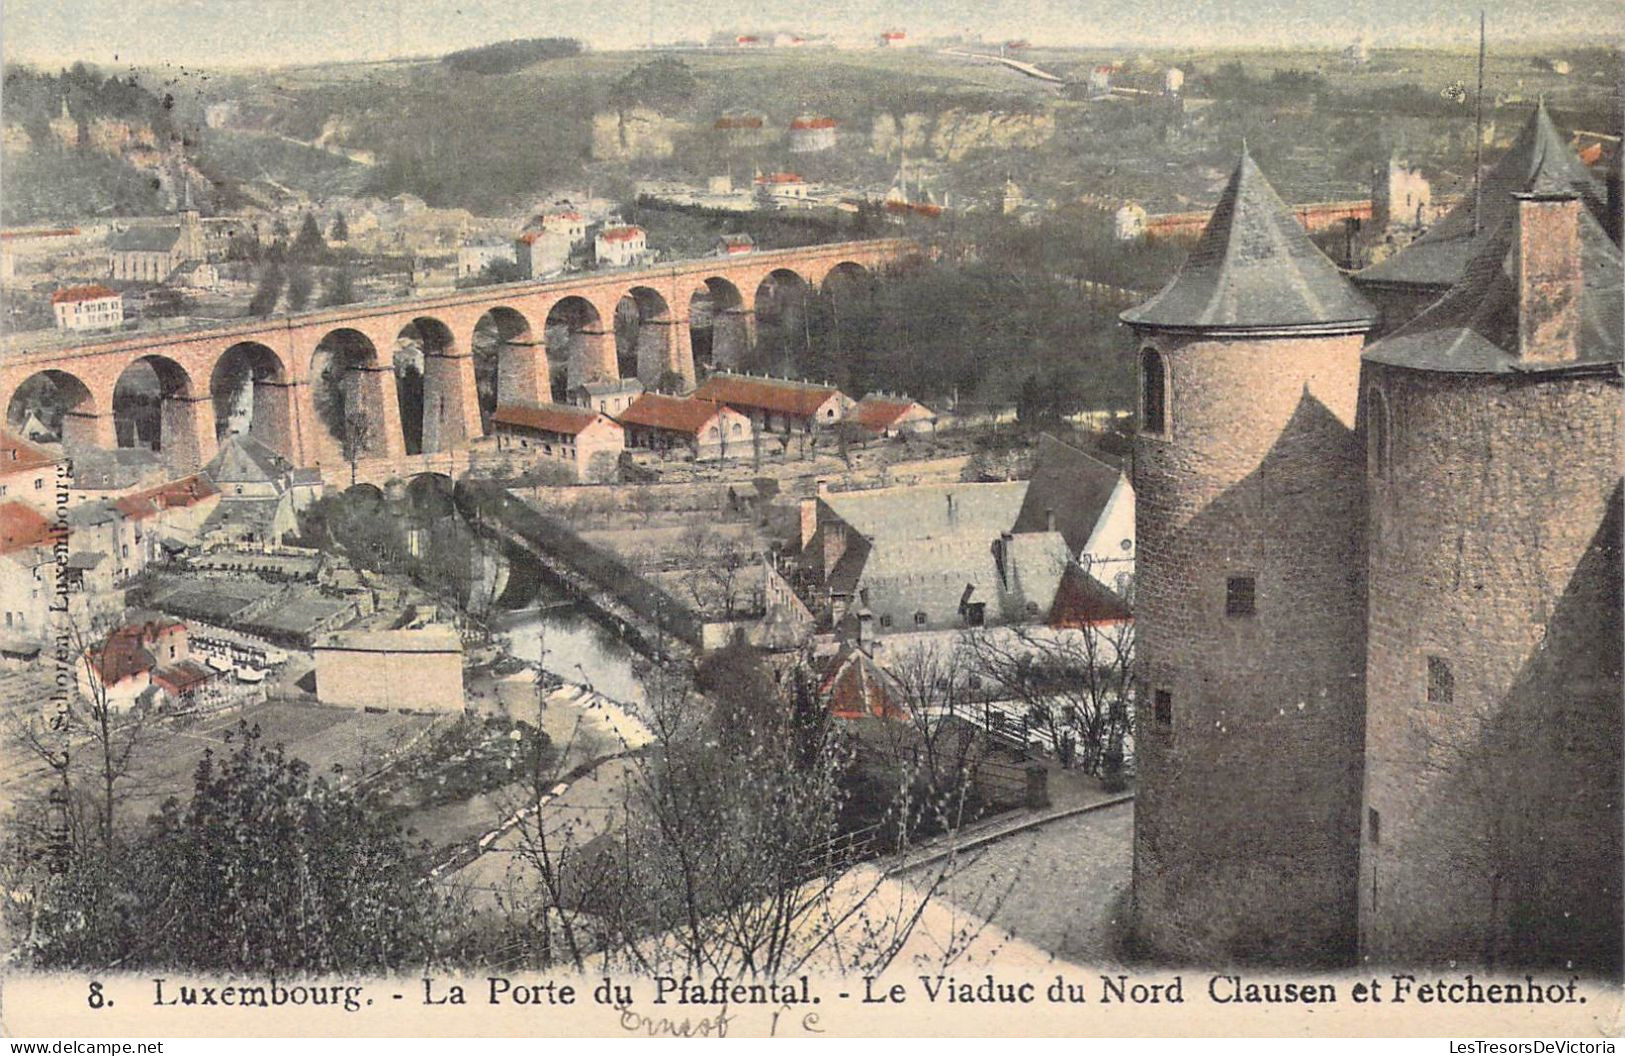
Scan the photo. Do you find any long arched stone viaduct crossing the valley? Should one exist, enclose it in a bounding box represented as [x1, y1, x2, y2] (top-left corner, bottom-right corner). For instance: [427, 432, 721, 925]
[0, 239, 920, 471]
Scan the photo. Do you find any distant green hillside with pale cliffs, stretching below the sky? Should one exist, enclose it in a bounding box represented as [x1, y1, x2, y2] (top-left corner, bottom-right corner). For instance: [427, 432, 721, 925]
[5, 41, 1620, 224]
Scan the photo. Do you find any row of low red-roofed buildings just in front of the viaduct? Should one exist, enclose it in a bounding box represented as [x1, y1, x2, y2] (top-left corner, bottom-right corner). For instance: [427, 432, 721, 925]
[491, 372, 936, 481]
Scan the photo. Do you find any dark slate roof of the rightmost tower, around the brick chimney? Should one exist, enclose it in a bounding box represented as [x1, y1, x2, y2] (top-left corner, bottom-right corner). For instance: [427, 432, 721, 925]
[1365, 194, 1625, 374]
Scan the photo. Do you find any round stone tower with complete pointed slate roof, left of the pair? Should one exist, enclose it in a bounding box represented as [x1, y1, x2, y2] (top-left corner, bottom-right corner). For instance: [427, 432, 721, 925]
[1123, 151, 1376, 963]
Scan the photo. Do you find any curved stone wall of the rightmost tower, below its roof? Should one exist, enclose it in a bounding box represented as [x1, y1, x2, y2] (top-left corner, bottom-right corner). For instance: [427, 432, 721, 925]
[1360, 366, 1622, 968]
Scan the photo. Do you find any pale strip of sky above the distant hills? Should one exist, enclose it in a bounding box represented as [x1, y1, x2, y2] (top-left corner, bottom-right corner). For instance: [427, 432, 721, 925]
[0, 0, 1605, 67]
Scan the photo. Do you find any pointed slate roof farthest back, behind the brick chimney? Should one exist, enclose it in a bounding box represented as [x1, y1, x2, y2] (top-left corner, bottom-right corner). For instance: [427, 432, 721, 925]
[1354, 99, 1607, 289]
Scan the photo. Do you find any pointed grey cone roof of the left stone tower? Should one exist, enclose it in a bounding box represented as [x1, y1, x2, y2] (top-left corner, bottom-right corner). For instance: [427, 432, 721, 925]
[1120, 149, 1376, 333]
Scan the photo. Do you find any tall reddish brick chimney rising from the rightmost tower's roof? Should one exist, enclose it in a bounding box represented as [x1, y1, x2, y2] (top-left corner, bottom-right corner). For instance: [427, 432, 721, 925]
[1513, 188, 1583, 362]
